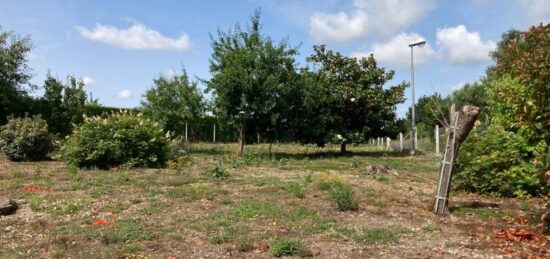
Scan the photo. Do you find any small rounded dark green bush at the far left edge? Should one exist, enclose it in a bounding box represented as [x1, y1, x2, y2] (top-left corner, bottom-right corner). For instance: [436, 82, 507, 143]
[0, 116, 52, 161]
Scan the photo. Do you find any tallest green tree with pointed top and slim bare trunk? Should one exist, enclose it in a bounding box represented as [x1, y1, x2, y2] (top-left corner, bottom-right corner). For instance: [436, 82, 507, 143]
[206, 11, 298, 156]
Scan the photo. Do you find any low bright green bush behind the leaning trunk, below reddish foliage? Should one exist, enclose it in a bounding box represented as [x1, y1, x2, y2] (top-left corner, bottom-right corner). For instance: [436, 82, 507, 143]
[453, 125, 549, 198]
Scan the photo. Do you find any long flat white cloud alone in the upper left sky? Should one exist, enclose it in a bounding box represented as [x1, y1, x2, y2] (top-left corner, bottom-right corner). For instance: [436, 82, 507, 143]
[76, 23, 191, 50]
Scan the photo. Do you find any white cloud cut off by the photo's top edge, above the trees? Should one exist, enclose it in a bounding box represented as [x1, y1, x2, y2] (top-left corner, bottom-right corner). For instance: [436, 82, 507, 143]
[309, 0, 435, 42]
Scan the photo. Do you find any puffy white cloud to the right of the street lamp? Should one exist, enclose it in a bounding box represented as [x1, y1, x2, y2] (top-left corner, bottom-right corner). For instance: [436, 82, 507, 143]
[436, 25, 496, 65]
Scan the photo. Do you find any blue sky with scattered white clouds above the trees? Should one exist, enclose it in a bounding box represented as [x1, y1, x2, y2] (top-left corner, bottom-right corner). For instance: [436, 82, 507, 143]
[0, 0, 550, 116]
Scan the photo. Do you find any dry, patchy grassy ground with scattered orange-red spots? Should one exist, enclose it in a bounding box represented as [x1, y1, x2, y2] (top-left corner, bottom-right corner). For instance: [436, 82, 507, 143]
[0, 143, 544, 258]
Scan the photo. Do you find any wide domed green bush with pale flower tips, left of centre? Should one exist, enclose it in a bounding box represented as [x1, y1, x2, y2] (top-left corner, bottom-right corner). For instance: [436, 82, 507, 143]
[62, 111, 170, 169]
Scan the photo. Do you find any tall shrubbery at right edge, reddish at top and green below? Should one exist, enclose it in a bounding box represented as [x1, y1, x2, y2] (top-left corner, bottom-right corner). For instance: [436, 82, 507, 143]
[455, 25, 550, 197]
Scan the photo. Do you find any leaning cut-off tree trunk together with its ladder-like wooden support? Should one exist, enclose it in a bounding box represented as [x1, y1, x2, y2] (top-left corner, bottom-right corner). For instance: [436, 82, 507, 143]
[433, 106, 479, 215]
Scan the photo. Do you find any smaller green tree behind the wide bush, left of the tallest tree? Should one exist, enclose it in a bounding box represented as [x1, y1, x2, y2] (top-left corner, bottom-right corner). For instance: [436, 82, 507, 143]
[141, 69, 205, 136]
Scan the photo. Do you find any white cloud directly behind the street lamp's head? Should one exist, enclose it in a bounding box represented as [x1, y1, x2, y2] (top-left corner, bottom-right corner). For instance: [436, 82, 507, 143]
[352, 33, 437, 68]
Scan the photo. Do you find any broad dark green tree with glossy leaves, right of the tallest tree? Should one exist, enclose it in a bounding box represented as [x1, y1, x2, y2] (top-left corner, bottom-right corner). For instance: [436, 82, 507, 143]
[302, 45, 407, 152]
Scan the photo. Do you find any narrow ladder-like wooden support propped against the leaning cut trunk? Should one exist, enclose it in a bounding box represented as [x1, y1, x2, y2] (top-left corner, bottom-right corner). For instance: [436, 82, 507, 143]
[434, 112, 459, 214]
